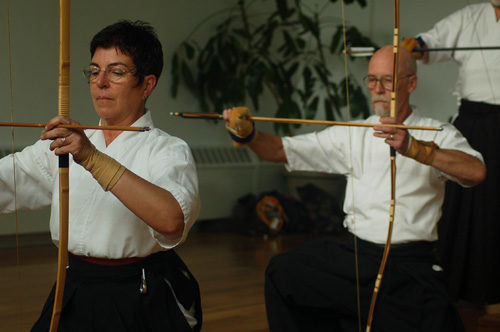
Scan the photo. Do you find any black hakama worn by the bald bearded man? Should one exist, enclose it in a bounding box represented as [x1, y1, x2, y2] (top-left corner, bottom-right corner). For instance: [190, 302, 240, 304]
[266, 239, 463, 332]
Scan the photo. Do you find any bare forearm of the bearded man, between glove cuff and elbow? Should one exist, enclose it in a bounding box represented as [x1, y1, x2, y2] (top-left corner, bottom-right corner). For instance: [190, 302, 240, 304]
[431, 149, 486, 186]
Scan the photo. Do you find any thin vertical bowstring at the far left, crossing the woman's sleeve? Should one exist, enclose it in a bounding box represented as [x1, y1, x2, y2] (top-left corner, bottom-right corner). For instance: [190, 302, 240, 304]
[6, 0, 23, 330]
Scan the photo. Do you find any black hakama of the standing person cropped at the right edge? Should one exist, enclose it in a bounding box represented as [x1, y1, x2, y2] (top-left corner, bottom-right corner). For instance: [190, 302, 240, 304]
[438, 100, 500, 305]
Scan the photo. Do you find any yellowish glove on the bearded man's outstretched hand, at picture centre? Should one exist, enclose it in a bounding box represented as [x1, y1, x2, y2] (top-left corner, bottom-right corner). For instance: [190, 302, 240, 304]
[226, 106, 256, 146]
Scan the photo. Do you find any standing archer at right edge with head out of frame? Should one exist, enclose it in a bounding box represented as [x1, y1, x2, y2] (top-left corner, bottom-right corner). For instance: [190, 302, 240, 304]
[402, 0, 500, 309]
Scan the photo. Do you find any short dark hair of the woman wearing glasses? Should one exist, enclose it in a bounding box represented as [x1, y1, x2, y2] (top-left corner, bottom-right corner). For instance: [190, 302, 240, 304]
[90, 20, 163, 84]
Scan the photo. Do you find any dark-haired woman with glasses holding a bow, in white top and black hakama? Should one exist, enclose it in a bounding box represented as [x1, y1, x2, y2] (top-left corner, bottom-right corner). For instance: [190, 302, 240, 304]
[0, 21, 201, 331]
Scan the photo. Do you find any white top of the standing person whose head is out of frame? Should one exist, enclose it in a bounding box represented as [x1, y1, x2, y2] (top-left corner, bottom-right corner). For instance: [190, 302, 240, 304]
[418, 3, 500, 105]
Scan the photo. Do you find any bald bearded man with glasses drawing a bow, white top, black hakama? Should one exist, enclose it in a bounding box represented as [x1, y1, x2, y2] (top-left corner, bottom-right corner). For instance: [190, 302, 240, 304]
[223, 46, 486, 332]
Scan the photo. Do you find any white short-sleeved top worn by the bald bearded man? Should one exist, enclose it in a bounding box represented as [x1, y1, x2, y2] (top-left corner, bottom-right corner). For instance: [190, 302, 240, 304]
[283, 108, 482, 244]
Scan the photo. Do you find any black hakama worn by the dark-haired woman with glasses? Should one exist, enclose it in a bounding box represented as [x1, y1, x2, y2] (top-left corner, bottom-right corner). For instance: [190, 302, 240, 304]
[32, 250, 201, 332]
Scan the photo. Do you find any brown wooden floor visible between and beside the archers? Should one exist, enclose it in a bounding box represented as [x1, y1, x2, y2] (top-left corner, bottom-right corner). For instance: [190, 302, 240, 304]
[0, 232, 493, 332]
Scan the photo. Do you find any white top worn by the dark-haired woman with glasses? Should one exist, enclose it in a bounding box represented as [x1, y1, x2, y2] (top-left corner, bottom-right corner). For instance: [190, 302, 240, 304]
[0, 111, 200, 258]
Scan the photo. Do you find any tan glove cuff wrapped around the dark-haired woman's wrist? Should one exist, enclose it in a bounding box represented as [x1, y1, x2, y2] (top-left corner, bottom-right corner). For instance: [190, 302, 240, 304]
[80, 145, 125, 191]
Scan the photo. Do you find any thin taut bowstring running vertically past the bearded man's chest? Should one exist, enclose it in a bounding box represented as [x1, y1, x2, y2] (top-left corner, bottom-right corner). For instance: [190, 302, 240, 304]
[341, 0, 361, 332]
